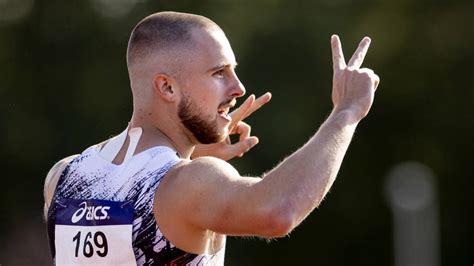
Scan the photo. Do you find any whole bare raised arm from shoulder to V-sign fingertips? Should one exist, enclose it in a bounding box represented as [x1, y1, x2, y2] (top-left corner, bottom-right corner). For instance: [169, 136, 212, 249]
[155, 36, 379, 237]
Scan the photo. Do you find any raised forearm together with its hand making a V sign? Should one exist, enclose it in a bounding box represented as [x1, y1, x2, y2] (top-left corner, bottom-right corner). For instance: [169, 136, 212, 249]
[248, 36, 379, 231]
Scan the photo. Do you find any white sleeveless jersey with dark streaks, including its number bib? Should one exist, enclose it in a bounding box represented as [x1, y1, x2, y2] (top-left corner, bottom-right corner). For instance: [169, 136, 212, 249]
[48, 140, 225, 266]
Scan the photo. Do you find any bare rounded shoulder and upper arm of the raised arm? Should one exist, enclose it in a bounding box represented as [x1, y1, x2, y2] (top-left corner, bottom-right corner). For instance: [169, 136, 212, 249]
[153, 157, 260, 245]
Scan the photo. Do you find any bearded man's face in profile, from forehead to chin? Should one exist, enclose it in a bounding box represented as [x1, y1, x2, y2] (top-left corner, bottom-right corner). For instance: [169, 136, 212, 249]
[178, 29, 245, 144]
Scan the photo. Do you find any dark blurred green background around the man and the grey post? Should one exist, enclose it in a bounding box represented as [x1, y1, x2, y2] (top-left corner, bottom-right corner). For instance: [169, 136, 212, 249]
[0, 0, 474, 265]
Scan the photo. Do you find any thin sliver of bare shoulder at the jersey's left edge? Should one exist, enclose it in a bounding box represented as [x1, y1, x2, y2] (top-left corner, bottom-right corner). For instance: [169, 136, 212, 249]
[43, 154, 79, 219]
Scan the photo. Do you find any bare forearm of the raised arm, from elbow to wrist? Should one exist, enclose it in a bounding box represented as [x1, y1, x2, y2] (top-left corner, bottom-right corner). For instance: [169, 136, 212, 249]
[256, 112, 357, 227]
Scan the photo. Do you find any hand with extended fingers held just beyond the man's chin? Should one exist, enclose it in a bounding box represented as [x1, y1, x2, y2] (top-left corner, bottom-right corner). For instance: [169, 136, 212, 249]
[191, 92, 272, 161]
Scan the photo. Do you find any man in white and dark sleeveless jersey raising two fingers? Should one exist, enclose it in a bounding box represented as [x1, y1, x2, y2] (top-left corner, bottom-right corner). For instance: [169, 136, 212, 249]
[45, 12, 379, 265]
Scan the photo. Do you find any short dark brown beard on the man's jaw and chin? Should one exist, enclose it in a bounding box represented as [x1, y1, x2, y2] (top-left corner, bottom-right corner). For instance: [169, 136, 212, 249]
[178, 95, 227, 144]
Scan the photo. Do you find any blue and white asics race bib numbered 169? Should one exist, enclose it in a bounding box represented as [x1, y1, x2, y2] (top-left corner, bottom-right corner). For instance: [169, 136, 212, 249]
[54, 199, 136, 266]
